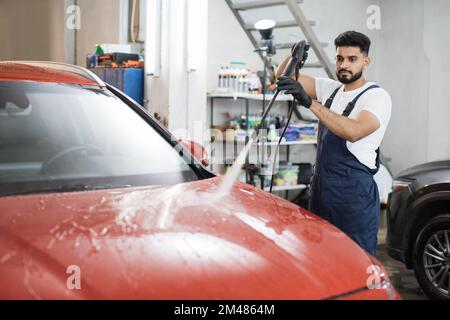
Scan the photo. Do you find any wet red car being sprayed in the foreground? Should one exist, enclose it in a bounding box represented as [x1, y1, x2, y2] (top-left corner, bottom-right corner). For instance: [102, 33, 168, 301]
[0, 62, 399, 300]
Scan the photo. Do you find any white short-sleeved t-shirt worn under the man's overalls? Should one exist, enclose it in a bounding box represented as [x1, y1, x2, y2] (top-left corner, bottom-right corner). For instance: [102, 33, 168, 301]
[316, 78, 392, 169]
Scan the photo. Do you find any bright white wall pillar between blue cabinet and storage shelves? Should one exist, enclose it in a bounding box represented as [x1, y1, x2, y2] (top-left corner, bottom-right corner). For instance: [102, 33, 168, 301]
[147, 0, 208, 142]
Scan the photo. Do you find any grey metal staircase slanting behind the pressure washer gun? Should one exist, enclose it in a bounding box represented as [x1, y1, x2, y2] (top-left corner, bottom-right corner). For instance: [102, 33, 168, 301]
[225, 0, 336, 79]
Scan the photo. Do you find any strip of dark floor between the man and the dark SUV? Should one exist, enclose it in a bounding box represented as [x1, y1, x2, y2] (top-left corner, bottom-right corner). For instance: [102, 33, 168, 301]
[377, 210, 428, 300]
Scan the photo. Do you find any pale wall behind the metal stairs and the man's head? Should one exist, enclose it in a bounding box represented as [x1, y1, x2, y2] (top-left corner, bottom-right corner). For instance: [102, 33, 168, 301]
[208, 0, 380, 90]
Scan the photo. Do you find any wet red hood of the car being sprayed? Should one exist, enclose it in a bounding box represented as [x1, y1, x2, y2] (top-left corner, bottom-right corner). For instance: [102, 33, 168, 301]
[0, 177, 373, 299]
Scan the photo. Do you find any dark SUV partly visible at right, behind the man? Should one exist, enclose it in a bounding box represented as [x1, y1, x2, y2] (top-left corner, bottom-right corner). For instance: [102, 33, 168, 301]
[387, 160, 450, 300]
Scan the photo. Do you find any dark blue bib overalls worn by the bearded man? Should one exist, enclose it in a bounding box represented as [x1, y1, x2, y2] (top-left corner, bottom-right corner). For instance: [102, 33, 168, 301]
[309, 85, 380, 255]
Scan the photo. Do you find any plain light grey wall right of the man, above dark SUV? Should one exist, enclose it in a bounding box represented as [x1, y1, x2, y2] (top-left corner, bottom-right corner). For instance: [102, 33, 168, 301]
[379, 0, 450, 173]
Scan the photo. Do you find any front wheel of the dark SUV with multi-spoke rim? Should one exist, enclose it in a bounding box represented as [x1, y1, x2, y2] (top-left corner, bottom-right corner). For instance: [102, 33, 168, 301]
[413, 214, 450, 300]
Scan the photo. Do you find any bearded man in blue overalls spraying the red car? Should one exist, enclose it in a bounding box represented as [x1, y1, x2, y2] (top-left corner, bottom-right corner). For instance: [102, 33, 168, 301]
[277, 31, 392, 255]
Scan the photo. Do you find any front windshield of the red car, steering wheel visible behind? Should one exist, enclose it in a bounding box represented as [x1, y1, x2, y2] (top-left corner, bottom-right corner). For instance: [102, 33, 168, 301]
[0, 82, 199, 195]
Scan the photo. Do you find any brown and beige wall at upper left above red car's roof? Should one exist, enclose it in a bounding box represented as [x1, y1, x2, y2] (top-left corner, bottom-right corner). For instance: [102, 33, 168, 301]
[0, 0, 120, 66]
